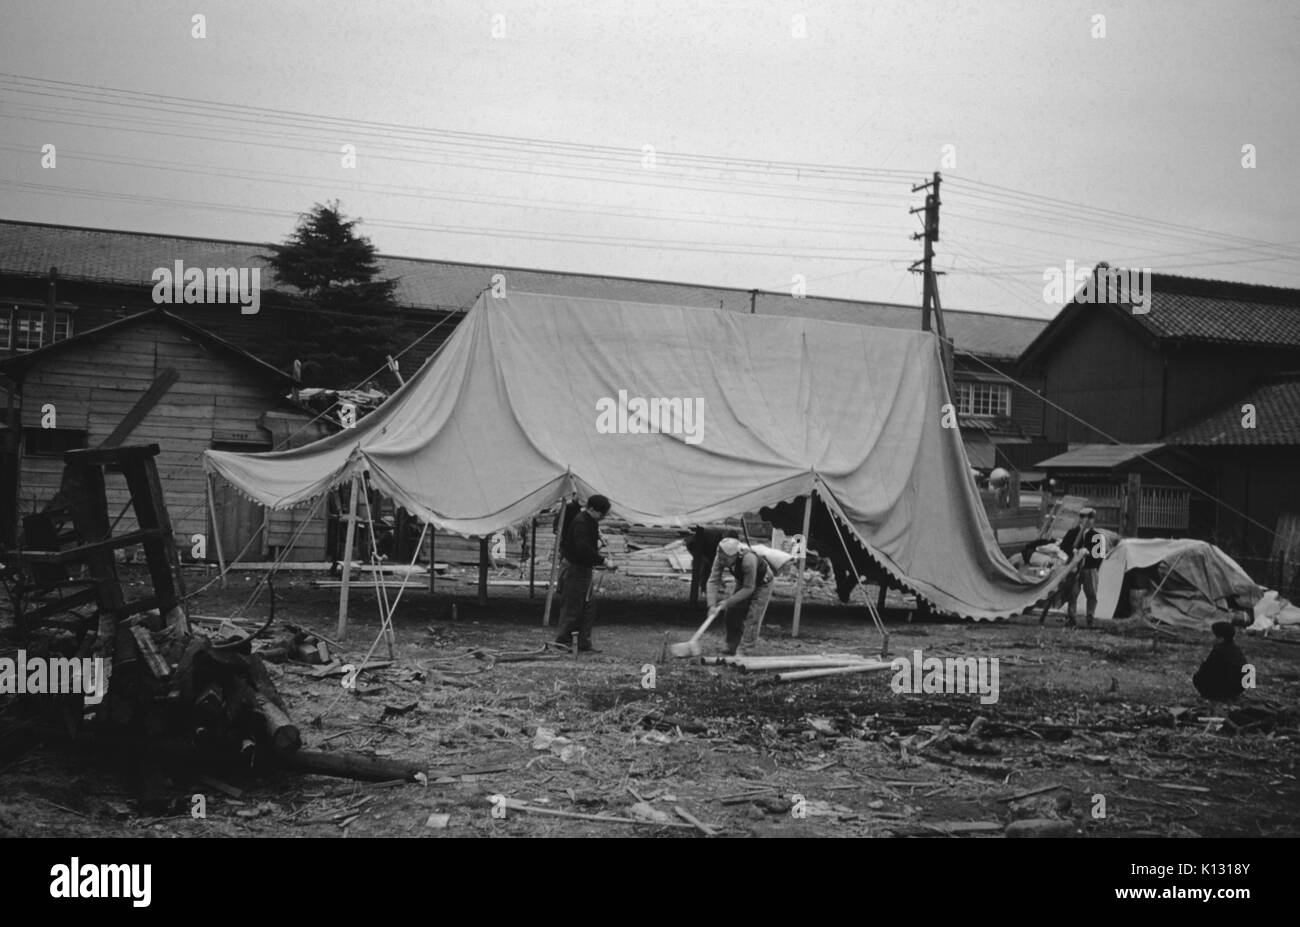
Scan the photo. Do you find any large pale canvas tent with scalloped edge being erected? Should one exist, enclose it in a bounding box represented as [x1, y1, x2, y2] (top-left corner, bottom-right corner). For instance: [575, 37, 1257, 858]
[205, 293, 1060, 619]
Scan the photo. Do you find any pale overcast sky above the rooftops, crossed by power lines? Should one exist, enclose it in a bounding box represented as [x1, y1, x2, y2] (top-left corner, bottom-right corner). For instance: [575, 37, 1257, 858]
[0, 0, 1300, 317]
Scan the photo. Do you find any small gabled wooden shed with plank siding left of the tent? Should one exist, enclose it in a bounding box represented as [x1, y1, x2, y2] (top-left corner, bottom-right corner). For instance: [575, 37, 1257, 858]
[0, 309, 326, 560]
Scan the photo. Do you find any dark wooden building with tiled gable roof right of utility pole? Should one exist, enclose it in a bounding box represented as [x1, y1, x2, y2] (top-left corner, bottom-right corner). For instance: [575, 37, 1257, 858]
[1019, 263, 1300, 581]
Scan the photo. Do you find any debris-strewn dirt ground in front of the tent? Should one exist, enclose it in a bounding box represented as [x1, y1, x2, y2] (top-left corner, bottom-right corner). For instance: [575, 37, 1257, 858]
[0, 571, 1300, 837]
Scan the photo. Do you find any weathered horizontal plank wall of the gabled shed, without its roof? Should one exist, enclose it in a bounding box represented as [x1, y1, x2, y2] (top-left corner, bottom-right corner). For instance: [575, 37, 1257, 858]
[20, 322, 325, 562]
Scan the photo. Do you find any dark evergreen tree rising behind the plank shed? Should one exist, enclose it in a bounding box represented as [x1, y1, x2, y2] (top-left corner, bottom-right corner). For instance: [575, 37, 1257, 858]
[264, 200, 398, 389]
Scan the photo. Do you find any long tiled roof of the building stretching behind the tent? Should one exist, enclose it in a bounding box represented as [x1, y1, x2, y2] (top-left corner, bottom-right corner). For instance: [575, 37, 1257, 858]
[0, 220, 1047, 359]
